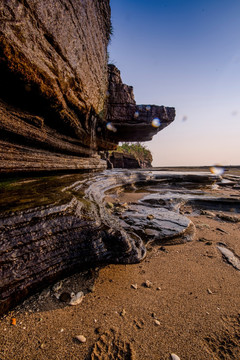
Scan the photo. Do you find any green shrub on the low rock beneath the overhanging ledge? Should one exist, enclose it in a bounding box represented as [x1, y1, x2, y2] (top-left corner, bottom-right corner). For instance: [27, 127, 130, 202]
[117, 142, 153, 168]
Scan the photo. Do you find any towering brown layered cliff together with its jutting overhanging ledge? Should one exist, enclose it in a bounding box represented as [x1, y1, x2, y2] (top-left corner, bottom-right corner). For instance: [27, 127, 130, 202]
[0, 0, 175, 173]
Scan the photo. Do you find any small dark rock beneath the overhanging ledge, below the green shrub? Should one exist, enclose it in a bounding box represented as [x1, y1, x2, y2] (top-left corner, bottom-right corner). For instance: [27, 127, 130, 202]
[107, 151, 141, 169]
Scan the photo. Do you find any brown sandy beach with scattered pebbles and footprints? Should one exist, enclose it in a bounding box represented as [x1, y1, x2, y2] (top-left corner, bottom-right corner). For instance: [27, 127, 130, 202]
[0, 170, 240, 360]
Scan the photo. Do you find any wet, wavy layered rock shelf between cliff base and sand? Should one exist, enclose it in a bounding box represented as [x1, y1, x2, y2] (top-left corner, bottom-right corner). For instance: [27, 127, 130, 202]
[0, 170, 227, 313]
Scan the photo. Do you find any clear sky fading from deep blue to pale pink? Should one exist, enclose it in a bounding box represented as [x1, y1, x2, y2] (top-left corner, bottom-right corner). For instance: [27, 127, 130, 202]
[109, 0, 240, 166]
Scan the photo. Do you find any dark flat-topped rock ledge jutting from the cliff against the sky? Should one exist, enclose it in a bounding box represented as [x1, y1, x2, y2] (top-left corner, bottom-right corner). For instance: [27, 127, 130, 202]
[107, 65, 175, 142]
